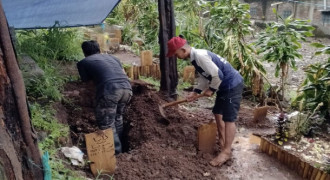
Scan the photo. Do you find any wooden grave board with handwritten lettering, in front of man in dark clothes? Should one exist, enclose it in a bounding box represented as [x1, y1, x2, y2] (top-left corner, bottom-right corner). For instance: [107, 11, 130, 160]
[85, 128, 116, 176]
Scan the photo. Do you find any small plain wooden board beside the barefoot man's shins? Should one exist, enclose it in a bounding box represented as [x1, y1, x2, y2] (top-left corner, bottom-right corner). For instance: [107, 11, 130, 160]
[197, 122, 217, 153]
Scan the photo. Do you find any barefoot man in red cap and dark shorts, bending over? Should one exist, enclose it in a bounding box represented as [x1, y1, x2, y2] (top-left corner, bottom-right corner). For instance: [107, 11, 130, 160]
[167, 37, 244, 166]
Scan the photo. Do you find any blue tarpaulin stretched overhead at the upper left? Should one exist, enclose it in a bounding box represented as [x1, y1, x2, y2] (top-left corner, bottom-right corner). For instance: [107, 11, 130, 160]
[0, 0, 120, 29]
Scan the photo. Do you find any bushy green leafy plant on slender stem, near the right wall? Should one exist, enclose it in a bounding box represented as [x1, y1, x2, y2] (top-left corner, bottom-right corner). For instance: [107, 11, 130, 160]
[256, 9, 314, 100]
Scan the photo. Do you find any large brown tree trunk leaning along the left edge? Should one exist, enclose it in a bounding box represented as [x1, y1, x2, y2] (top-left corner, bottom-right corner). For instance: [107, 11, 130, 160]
[0, 2, 43, 180]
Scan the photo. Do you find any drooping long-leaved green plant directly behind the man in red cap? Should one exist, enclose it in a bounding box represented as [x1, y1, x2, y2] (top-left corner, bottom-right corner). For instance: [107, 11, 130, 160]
[205, 0, 266, 95]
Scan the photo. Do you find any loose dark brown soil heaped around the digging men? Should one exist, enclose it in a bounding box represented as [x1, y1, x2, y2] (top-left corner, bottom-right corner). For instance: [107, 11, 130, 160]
[65, 82, 227, 179]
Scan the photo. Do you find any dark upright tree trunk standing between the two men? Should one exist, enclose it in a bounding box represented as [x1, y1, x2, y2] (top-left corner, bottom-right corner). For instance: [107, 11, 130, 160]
[158, 0, 178, 99]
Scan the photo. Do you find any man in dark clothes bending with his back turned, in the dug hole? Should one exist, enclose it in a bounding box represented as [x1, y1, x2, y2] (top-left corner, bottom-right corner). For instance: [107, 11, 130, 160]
[77, 41, 132, 154]
